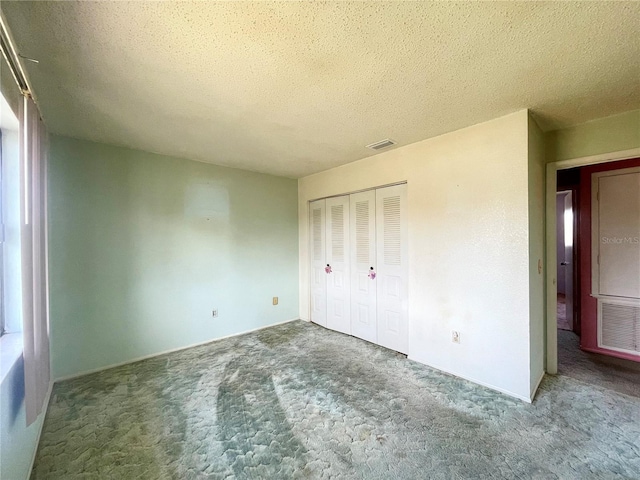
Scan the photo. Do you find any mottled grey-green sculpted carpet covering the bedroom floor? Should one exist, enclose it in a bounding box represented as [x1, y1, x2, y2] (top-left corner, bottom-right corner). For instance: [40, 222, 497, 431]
[32, 321, 640, 480]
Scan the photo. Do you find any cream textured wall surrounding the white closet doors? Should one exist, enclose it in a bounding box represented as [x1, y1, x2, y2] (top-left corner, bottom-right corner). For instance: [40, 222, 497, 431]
[298, 110, 541, 399]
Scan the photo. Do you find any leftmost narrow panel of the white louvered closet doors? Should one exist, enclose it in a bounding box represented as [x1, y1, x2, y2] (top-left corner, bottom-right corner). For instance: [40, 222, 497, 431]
[309, 200, 327, 327]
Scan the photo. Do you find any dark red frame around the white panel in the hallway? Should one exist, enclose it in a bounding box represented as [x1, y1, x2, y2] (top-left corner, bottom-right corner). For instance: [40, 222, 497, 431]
[579, 158, 640, 362]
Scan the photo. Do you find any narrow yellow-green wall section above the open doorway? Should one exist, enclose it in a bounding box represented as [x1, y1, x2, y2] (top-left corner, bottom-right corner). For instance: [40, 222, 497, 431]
[545, 110, 640, 162]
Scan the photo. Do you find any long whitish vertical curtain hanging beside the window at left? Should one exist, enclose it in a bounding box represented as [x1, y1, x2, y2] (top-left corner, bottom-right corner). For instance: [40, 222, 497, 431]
[19, 97, 50, 425]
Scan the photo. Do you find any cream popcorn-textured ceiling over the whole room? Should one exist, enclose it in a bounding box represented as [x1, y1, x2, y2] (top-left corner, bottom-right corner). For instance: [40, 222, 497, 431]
[2, 1, 640, 177]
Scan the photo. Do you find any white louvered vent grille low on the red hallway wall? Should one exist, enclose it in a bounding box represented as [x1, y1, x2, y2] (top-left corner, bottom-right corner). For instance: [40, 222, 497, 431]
[598, 298, 640, 355]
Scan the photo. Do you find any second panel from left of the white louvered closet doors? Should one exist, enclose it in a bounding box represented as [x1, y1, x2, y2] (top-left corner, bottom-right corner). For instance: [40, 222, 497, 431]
[325, 195, 351, 334]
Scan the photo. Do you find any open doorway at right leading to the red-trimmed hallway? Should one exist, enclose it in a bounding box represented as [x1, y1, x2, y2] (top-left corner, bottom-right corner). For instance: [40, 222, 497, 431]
[547, 154, 640, 396]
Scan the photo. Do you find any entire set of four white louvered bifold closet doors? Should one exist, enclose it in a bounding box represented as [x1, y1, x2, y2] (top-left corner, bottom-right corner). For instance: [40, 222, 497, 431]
[309, 185, 409, 353]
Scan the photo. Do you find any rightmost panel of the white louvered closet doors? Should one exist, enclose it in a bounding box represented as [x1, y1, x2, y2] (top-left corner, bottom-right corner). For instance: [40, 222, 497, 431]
[376, 185, 409, 353]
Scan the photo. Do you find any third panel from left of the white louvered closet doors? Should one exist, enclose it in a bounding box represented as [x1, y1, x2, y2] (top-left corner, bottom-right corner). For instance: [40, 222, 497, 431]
[349, 190, 378, 343]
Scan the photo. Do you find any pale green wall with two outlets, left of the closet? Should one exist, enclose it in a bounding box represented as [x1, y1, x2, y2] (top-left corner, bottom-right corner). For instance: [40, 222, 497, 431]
[49, 136, 298, 379]
